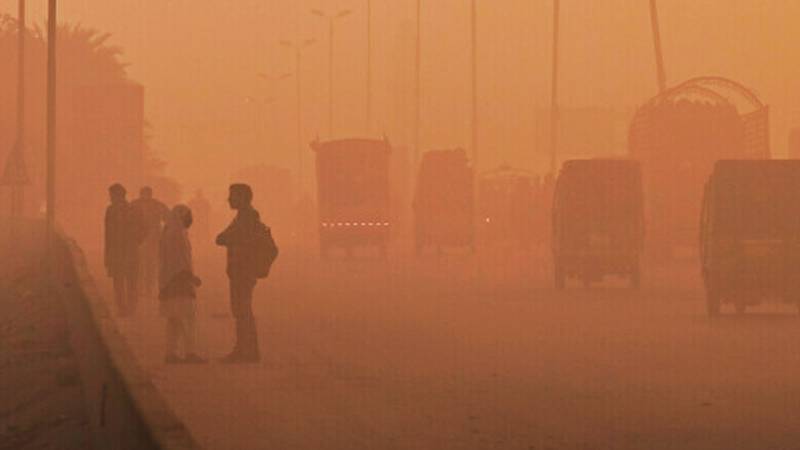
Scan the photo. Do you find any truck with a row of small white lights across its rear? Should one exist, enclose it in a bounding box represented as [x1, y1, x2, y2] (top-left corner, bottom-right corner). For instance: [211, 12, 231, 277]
[311, 139, 392, 258]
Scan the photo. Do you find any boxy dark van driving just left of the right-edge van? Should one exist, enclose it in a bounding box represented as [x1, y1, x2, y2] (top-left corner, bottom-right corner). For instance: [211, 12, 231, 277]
[552, 159, 644, 289]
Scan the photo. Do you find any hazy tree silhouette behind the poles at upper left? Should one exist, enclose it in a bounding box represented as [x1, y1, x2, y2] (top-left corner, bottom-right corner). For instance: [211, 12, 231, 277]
[0, 15, 176, 250]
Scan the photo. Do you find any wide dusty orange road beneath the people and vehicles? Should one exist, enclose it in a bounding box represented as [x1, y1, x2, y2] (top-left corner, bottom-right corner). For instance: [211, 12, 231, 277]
[97, 246, 800, 450]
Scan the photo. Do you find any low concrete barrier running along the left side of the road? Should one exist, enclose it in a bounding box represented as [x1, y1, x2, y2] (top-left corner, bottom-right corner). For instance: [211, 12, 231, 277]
[50, 234, 200, 450]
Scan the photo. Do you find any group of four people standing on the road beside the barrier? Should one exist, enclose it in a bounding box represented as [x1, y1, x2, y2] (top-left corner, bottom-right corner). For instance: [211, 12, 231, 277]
[105, 184, 278, 364]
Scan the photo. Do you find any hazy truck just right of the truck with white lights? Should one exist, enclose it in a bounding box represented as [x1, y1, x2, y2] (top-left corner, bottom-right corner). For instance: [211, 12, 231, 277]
[413, 149, 475, 255]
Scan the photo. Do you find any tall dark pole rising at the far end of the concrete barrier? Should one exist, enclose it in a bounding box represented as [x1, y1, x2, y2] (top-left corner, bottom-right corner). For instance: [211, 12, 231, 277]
[46, 0, 58, 253]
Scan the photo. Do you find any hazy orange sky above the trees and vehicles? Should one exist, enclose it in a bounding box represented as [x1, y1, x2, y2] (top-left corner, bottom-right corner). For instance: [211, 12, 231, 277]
[10, 0, 800, 192]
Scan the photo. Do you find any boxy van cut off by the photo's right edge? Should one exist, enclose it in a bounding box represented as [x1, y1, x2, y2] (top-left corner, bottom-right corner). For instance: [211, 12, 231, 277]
[700, 160, 800, 316]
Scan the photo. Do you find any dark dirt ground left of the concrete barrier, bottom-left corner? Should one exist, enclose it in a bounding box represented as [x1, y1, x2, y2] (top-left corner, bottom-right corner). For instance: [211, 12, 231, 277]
[0, 272, 90, 450]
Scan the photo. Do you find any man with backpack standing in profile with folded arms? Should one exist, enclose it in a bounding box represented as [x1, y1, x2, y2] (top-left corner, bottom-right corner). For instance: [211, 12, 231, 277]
[217, 184, 278, 364]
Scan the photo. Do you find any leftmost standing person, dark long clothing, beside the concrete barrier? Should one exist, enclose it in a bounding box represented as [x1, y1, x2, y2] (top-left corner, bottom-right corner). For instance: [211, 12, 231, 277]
[105, 183, 144, 317]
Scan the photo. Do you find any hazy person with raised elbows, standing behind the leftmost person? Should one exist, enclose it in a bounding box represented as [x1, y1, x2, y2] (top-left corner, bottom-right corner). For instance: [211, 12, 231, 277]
[131, 186, 169, 297]
